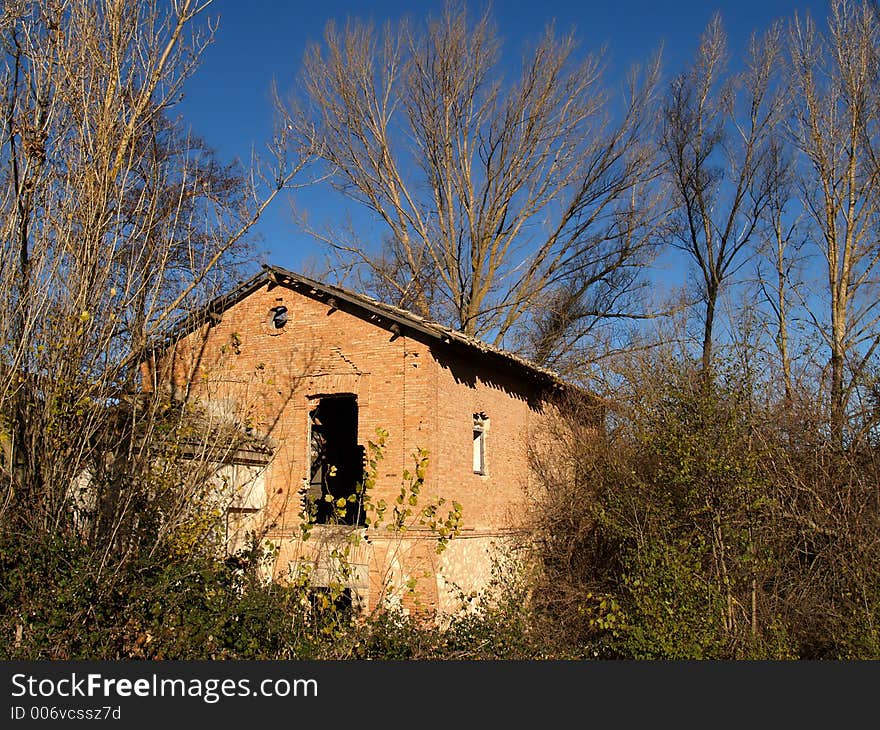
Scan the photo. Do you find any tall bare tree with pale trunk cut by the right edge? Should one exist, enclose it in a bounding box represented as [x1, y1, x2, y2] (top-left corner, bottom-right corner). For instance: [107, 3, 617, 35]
[790, 0, 880, 444]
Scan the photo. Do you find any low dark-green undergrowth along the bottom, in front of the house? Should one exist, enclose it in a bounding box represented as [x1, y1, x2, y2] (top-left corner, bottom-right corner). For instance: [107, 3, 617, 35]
[0, 524, 564, 660]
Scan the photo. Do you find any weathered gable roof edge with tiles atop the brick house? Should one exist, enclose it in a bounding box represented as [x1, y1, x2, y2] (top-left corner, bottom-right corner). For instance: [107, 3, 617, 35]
[152, 264, 569, 388]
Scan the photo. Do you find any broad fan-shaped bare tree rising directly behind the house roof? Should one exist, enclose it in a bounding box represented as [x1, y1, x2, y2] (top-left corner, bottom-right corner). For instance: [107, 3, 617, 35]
[288, 0, 658, 360]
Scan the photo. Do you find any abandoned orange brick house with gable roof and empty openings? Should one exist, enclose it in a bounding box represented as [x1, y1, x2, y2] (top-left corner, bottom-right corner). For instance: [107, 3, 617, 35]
[147, 266, 580, 611]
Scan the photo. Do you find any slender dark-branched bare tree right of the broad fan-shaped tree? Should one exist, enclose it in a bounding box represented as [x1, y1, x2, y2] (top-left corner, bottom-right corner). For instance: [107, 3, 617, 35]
[660, 15, 781, 377]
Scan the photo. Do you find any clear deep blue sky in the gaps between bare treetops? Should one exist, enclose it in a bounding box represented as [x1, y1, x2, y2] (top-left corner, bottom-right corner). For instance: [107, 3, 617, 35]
[179, 0, 827, 271]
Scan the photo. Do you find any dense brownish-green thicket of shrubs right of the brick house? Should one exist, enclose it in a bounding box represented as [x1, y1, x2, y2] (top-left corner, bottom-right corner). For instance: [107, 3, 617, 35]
[535, 369, 880, 659]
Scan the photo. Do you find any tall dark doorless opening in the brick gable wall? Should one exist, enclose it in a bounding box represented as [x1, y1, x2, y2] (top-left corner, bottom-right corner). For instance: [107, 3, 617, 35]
[309, 395, 364, 525]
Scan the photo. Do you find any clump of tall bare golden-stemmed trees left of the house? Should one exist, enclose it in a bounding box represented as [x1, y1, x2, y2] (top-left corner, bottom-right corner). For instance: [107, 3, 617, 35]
[0, 0, 300, 551]
